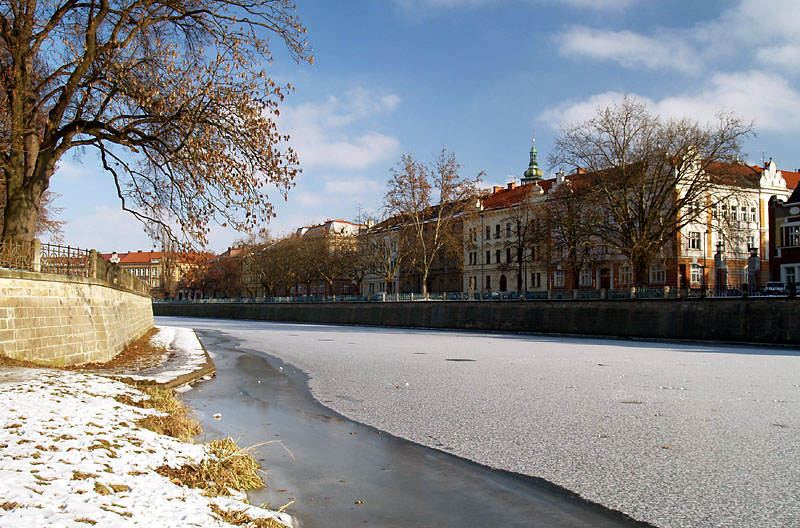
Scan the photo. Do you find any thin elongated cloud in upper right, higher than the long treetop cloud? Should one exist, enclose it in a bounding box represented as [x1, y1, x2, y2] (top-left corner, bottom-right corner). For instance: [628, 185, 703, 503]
[557, 26, 701, 72]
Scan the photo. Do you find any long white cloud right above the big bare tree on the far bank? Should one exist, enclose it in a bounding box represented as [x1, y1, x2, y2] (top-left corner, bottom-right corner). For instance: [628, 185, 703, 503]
[541, 71, 800, 131]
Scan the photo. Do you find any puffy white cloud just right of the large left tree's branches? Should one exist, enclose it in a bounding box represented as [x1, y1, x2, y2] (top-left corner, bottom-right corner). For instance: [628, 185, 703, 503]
[279, 88, 400, 169]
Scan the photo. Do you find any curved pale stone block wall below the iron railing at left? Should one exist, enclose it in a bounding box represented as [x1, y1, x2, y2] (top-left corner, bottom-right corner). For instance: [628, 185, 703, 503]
[0, 269, 153, 366]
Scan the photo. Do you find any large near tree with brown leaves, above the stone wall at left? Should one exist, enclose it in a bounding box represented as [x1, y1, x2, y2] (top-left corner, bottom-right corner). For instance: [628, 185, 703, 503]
[0, 0, 311, 244]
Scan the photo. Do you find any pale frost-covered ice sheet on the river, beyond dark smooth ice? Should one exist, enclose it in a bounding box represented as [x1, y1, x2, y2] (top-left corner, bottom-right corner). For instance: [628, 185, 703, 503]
[158, 318, 800, 527]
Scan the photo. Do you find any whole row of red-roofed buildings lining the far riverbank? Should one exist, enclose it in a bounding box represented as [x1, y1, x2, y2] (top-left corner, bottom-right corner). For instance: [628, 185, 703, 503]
[104, 143, 800, 298]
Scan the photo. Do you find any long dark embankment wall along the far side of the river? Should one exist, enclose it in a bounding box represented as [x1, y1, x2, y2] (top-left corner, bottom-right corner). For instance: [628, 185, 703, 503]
[153, 298, 800, 346]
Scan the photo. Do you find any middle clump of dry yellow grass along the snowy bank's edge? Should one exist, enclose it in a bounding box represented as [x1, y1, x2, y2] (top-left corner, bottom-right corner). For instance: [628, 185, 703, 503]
[156, 437, 264, 496]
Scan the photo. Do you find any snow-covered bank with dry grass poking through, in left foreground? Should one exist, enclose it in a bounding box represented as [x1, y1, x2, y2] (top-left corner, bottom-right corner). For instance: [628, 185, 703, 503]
[0, 368, 291, 528]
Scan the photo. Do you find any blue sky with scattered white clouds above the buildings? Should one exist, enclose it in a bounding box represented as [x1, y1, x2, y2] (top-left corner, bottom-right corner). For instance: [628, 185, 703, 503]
[51, 0, 800, 251]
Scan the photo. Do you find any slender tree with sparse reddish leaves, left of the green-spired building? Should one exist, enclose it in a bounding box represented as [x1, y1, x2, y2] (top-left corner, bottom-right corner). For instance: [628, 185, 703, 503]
[383, 149, 481, 294]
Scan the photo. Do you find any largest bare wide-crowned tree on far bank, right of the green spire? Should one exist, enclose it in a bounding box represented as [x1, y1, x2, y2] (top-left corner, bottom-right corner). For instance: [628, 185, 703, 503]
[550, 97, 752, 285]
